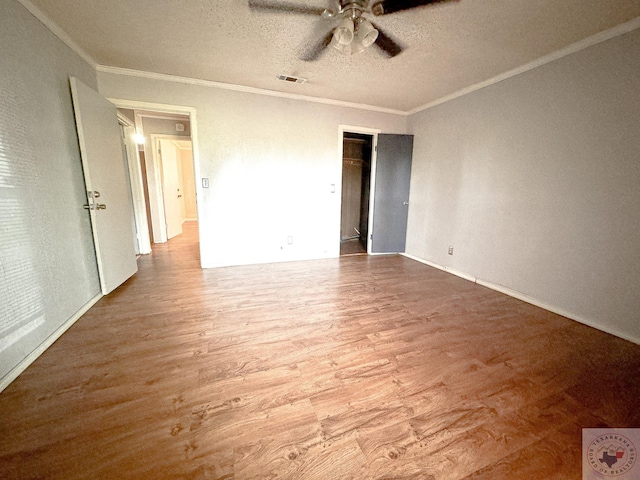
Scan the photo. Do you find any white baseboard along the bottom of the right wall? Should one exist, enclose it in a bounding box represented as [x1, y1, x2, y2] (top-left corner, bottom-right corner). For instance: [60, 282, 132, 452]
[401, 253, 640, 345]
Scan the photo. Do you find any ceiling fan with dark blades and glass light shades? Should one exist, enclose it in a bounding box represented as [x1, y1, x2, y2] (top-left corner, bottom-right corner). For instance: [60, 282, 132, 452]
[249, 0, 459, 62]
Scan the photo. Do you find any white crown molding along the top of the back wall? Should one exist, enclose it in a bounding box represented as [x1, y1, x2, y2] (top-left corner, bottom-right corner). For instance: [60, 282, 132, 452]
[96, 65, 407, 116]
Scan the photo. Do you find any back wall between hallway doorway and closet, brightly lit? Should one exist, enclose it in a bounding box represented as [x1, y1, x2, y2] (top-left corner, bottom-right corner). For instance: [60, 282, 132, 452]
[98, 72, 406, 267]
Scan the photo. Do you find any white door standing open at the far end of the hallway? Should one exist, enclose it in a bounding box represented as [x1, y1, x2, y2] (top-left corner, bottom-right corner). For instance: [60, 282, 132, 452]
[160, 139, 184, 239]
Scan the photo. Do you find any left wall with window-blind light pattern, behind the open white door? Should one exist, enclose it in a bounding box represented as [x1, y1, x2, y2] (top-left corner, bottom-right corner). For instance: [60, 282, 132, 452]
[0, 0, 100, 384]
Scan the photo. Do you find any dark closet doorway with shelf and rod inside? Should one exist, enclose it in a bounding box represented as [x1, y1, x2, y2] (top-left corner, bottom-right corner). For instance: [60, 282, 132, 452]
[340, 131, 374, 256]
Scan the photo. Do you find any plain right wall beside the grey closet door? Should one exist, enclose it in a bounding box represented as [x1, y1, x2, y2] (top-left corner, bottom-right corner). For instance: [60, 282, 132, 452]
[407, 30, 640, 342]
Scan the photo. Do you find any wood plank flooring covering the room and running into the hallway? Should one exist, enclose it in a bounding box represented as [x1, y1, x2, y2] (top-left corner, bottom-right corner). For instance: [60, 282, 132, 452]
[0, 222, 640, 480]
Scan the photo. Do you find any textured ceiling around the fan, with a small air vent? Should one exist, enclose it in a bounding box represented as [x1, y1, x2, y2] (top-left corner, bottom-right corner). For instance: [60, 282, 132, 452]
[31, 0, 640, 111]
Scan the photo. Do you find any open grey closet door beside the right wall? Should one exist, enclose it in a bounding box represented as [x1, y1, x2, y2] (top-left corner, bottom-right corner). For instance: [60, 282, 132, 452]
[371, 134, 413, 253]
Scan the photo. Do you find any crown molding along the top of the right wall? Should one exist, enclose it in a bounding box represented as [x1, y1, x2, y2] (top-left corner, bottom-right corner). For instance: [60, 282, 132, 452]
[405, 17, 640, 115]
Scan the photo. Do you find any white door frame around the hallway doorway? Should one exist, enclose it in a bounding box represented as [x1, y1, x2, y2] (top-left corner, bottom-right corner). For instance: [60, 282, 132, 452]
[108, 98, 204, 268]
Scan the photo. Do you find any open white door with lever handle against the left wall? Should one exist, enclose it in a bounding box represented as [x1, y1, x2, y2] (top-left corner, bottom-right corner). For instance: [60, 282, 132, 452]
[70, 77, 138, 295]
